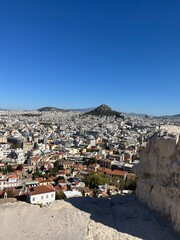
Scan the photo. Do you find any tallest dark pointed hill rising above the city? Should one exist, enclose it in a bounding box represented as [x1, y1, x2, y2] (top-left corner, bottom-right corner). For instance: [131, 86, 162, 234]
[84, 104, 123, 117]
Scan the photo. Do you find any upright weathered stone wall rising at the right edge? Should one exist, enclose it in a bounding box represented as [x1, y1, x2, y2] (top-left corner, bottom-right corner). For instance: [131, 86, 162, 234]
[134, 126, 180, 233]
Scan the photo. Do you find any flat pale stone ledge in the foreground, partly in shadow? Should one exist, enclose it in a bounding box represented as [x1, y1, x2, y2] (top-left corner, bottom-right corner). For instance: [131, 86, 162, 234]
[0, 195, 177, 240]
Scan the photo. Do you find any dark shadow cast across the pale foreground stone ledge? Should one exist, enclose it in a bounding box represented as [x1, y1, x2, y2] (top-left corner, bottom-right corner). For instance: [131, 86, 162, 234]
[65, 195, 180, 240]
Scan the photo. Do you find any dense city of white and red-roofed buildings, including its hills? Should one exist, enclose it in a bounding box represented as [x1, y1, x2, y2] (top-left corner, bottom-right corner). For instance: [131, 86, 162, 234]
[0, 105, 173, 205]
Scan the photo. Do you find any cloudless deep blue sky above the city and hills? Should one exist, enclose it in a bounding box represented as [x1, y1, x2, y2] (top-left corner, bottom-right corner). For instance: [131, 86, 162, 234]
[0, 0, 180, 115]
